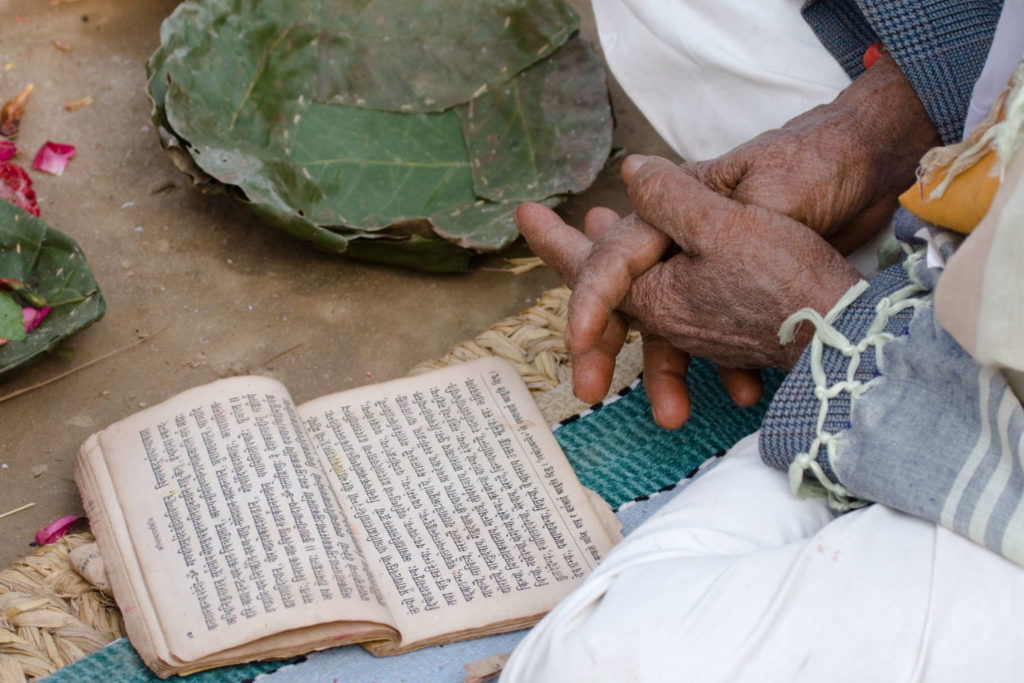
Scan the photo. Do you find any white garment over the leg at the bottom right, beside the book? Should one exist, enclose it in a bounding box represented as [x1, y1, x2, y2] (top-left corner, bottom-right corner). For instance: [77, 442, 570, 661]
[502, 434, 1024, 683]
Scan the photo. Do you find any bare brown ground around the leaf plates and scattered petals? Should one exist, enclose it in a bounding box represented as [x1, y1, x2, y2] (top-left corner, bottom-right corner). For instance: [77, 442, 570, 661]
[0, 0, 671, 567]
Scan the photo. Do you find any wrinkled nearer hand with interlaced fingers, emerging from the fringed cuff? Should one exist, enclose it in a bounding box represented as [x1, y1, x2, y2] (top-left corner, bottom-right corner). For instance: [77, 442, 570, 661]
[516, 157, 858, 428]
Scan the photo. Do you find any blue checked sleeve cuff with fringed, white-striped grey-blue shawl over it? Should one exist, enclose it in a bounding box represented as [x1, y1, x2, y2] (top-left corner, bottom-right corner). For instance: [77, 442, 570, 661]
[760, 211, 1024, 564]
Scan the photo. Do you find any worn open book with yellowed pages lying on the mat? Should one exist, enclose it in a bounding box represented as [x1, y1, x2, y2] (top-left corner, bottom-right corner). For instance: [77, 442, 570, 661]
[76, 358, 618, 677]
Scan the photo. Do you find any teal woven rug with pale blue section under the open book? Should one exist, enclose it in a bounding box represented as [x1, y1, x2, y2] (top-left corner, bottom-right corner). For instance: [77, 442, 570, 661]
[46, 359, 782, 683]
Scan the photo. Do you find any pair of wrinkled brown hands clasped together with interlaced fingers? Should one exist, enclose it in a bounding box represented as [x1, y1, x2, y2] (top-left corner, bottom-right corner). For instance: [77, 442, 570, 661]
[516, 55, 939, 428]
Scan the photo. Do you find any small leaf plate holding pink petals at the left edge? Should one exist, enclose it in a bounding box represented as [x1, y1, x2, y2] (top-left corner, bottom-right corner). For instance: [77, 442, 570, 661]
[0, 202, 106, 379]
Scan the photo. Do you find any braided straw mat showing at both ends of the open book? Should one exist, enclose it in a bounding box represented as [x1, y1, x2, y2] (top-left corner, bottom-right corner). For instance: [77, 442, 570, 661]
[0, 287, 618, 683]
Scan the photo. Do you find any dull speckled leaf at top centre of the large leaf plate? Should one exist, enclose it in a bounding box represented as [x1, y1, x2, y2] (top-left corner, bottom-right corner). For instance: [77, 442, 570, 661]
[316, 0, 580, 112]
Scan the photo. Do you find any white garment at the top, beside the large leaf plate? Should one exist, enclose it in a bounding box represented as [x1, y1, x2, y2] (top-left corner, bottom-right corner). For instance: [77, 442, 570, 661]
[593, 0, 850, 161]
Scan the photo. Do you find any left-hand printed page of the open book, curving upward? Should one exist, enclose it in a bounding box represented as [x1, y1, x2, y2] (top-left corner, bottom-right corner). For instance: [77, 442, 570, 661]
[89, 377, 390, 661]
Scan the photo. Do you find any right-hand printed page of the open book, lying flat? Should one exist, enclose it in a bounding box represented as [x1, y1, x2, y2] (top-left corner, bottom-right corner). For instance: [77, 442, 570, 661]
[299, 358, 613, 648]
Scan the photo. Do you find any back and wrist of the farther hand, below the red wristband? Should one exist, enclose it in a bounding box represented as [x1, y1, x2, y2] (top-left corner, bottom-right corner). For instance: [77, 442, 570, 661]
[692, 55, 941, 254]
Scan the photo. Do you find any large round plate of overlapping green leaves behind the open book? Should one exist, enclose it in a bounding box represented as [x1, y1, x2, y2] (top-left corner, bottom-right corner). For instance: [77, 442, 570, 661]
[147, 0, 611, 271]
